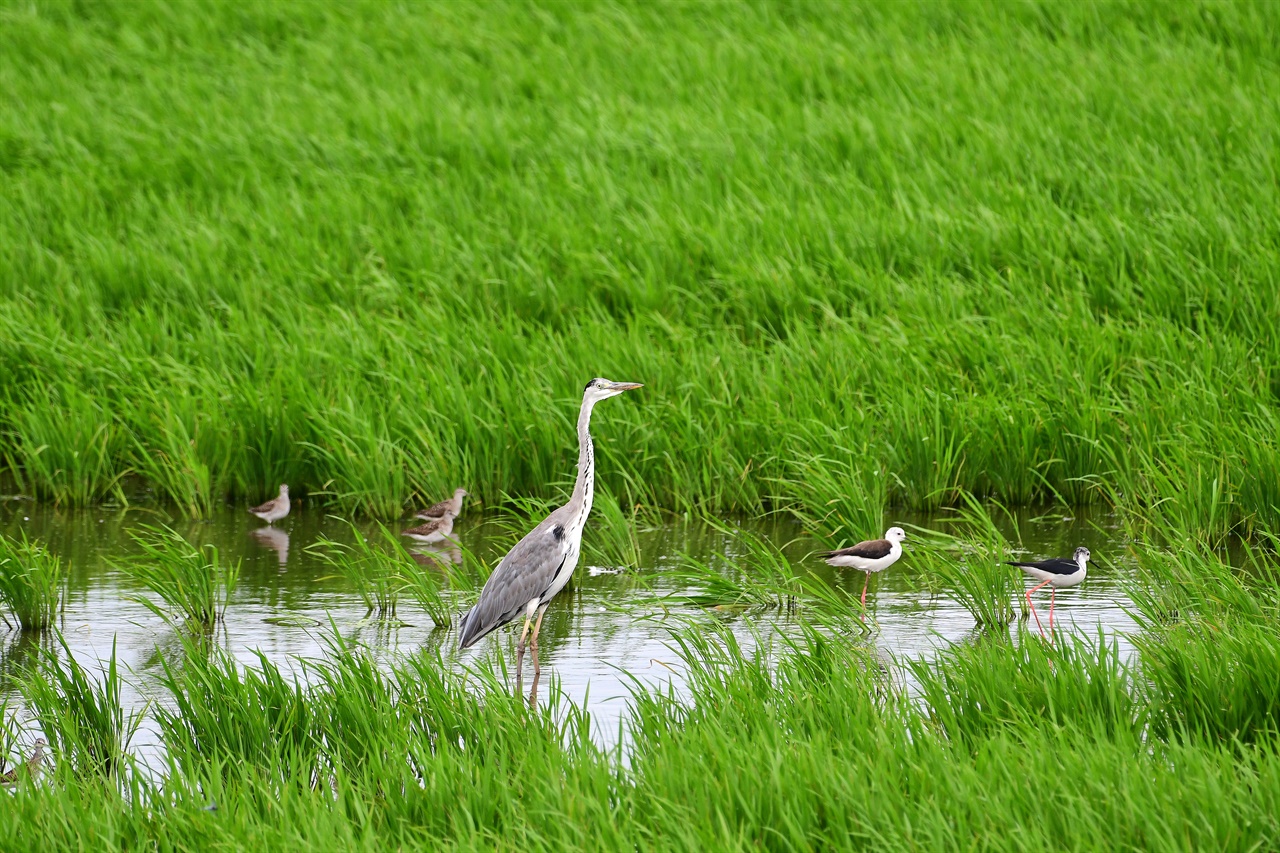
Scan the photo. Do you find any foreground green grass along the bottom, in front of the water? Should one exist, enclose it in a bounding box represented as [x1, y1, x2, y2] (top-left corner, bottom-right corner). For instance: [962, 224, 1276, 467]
[0, 537, 1280, 850]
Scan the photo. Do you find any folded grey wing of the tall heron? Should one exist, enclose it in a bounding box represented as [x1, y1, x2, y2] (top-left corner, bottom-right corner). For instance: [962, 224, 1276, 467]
[458, 512, 568, 648]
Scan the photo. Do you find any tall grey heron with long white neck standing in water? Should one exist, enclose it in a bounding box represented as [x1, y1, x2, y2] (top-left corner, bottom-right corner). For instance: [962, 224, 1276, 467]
[458, 379, 641, 678]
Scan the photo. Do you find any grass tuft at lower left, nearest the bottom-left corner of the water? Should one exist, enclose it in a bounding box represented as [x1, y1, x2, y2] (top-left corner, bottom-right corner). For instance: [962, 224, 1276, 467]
[20, 634, 143, 779]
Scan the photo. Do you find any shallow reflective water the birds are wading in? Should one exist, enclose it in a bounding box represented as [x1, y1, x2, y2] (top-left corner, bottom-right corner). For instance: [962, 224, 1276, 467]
[0, 501, 1134, 760]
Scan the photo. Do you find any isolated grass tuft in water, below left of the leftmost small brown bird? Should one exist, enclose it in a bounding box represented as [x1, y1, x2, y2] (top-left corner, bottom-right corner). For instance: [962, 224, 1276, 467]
[118, 525, 239, 629]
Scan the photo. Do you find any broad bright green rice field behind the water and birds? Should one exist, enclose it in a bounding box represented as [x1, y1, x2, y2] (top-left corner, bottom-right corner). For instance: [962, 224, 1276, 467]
[0, 1, 1280, 539]
